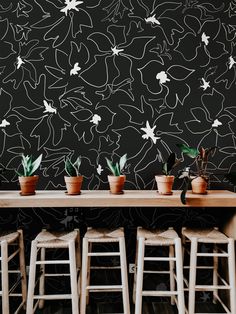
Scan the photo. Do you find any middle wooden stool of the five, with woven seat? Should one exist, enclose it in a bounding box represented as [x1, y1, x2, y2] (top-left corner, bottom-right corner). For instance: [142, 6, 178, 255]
[80, 228, 130, 314]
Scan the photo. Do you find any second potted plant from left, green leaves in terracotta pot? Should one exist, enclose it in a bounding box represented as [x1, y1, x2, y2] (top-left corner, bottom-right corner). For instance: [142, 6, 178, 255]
[64, 157, 83, 195]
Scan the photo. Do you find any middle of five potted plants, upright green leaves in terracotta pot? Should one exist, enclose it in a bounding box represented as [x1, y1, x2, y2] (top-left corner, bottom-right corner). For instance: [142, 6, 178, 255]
[106, 154, 127, 194]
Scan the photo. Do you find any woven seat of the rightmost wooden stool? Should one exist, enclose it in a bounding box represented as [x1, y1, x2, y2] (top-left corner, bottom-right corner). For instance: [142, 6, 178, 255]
[182, 228, 229, 243]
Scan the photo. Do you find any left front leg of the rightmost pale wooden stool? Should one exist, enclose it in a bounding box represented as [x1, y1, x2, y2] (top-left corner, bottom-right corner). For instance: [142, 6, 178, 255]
[188, 238, 198, 314]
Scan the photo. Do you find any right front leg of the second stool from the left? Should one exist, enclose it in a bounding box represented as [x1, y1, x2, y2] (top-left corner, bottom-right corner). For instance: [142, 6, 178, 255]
[69, 241, 79, 314]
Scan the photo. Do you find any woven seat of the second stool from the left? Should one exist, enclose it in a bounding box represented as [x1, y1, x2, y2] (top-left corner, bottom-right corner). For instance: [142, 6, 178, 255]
[35, 230, 77, 248]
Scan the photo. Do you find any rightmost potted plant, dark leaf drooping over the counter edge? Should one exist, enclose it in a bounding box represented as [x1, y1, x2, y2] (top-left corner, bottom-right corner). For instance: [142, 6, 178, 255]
[177, 144, 216, 204]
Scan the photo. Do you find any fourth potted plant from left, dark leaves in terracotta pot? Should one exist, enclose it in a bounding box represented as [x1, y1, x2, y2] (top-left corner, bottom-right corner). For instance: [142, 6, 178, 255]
[155, 153, 181, 195]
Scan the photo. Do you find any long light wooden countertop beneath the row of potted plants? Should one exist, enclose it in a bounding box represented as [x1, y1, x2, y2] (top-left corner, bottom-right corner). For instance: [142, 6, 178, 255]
[0, 190, 236, 208]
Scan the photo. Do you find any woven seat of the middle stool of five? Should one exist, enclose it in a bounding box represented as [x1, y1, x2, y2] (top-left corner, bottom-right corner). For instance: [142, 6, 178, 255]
[84, 228, 124, 242]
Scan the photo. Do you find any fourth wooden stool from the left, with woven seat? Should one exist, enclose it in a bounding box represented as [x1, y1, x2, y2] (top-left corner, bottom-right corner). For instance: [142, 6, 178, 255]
[133, 227, 185, 314]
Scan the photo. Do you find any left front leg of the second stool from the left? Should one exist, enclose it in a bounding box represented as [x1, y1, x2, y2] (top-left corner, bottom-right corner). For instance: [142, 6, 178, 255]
[26, 240, 38, 314]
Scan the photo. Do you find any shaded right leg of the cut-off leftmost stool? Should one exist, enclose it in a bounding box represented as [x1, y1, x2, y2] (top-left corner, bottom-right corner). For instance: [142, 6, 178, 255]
[18, 230, 27, 307]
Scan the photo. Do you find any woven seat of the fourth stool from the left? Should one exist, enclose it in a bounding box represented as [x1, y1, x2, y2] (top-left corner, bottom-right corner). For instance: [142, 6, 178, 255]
[137, 228, 178, 245]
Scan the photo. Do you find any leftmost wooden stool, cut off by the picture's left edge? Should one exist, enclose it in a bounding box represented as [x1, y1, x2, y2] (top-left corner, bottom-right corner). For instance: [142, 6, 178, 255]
[0, 230, 27, 314]
